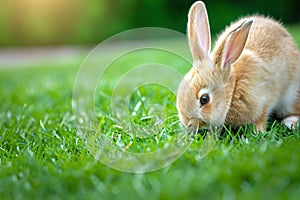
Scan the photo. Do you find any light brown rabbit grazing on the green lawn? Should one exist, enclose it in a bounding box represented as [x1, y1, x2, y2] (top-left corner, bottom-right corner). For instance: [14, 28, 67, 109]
[176, 1, 300, 132]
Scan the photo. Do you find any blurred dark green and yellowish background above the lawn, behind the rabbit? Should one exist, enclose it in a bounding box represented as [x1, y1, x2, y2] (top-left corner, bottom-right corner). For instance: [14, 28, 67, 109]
[0, 0, 300, 47]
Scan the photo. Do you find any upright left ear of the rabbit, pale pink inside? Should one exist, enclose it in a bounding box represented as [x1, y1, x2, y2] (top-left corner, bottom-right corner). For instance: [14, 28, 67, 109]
[187, 1, 211, 61]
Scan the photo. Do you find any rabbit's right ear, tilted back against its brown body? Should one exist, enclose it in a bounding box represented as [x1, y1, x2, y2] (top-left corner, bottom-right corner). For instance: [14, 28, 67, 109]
[222, 20, 253, 68]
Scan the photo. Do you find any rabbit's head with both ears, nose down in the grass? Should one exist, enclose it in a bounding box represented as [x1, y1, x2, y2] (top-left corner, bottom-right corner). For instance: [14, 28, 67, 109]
[176, 1, 252, 128]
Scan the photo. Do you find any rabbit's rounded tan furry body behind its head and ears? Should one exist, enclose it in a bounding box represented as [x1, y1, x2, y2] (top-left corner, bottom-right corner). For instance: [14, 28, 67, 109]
[213, 16, 300, 124]
